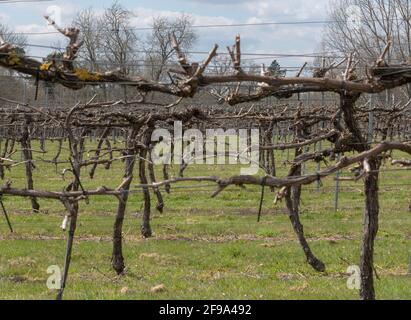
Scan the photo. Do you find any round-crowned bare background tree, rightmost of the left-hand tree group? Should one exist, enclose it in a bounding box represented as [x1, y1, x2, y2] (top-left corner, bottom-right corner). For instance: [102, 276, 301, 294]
[146, 14, 198, 81]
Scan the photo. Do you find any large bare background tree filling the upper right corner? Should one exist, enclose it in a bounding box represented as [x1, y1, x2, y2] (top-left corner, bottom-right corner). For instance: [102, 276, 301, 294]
[324, 0, 411, 97]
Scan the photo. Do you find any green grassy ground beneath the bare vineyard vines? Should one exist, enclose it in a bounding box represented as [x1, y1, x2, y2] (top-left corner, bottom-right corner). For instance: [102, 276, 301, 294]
[0, 140, 411, 299]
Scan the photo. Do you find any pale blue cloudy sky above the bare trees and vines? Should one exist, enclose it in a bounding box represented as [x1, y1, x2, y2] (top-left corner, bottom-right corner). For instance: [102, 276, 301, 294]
[0, 0, 330, 72]
